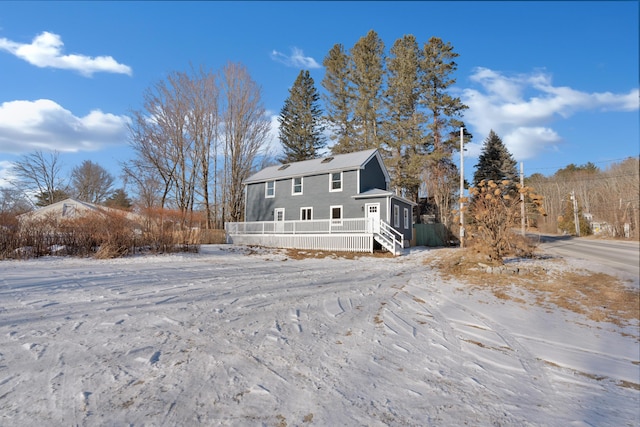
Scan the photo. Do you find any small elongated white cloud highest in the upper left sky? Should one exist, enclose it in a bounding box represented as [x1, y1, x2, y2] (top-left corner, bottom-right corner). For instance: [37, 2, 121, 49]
[0, 31, 132, 77]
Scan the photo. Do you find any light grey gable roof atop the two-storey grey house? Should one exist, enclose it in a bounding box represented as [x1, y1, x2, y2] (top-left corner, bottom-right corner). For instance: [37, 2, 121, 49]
[244, 148, 388, 184]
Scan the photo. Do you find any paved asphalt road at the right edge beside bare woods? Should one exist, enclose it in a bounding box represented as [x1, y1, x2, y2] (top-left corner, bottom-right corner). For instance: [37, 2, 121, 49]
[536, 235, 640, 279]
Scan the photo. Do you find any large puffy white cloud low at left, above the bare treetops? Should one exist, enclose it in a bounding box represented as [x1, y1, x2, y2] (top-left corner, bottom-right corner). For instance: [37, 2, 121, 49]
[0, 99, 129, 154]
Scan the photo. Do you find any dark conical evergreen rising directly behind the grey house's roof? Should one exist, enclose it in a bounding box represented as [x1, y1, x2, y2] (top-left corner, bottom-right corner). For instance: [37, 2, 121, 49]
[278, 70, 326, 163]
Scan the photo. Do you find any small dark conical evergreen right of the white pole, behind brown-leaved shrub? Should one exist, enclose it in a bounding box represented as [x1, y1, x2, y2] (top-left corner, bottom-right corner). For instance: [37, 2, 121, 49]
[473, 130, 518, 187]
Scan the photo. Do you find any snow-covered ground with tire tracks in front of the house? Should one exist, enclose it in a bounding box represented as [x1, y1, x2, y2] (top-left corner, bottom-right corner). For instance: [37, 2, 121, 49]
[0, 245, 640, 426]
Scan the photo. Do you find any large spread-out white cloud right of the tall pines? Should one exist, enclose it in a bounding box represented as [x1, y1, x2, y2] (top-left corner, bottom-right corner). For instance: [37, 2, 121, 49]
[461, 68, 640, 160]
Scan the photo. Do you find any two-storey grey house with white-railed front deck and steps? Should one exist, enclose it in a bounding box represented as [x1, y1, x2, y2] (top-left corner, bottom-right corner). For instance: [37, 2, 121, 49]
[225, 149, 415, 254]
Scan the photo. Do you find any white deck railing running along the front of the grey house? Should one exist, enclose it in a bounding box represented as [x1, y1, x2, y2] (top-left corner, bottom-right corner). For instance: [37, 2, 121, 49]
[224, 218, 373, 235]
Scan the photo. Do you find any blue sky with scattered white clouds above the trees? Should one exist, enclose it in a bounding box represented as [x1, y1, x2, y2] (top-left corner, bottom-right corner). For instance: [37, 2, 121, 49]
[0, 1, 640, 189]
